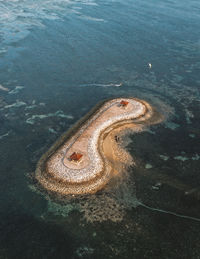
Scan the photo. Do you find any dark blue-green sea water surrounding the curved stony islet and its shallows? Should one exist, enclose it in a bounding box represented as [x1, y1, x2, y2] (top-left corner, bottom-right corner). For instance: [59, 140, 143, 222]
[0, 0, 200, 259]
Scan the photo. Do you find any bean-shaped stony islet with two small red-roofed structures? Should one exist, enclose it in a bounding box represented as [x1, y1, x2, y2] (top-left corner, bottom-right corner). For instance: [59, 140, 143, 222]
[36, 98, 155, 195]
